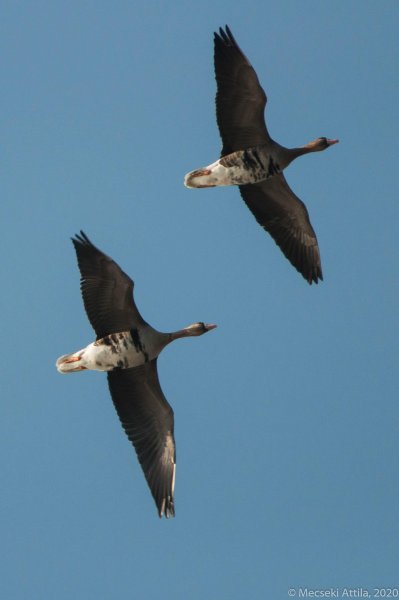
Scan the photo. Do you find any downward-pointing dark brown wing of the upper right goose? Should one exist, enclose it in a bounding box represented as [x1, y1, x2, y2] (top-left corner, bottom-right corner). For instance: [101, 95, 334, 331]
[240, 173, 323, 284]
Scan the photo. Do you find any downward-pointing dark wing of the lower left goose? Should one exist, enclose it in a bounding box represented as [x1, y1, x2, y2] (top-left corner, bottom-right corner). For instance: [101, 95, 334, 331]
[108, 359, 176, 518]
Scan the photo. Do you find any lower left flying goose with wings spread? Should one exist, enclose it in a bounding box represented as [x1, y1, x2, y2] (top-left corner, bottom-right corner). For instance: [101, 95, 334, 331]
[56, 231, 216, 518]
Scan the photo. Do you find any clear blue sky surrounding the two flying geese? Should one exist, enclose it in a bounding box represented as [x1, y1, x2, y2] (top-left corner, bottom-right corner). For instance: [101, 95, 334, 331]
[0, 0, 399, 600]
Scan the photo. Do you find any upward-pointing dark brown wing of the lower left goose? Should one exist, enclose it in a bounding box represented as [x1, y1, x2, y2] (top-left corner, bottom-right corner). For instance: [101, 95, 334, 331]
[72, 231, 144, 339]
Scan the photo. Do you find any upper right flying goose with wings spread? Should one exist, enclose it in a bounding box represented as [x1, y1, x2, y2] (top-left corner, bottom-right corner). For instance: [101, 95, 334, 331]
[184, 25, 339, 284]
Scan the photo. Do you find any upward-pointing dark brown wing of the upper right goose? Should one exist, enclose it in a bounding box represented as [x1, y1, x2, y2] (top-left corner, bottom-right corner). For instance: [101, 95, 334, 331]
[214, 25, 270, 156]
